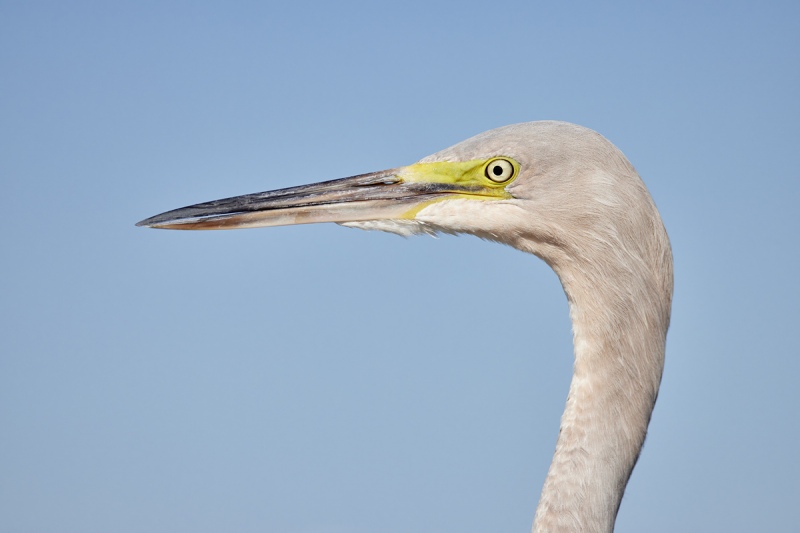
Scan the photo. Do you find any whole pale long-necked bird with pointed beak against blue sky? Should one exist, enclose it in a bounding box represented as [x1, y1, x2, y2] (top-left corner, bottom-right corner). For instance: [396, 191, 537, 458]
[137, 121, 673, 533]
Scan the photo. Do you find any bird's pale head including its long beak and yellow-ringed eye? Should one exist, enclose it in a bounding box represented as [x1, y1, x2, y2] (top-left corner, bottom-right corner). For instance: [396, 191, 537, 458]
[137, 121, 663, 276]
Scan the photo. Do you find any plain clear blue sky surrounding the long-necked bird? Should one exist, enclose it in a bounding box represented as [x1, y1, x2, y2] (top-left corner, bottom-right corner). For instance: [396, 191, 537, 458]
[0, 0, 800, 533]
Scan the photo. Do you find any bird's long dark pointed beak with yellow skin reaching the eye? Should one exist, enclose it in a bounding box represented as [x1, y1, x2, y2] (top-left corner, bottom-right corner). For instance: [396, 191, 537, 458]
[136, 159, 518, 230]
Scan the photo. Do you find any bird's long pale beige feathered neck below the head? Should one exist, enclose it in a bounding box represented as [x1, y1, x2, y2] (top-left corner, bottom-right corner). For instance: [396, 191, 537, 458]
[533, 256, 672, 533]
